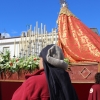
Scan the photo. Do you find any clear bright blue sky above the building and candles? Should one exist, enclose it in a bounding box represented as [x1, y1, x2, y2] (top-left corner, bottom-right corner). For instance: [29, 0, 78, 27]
[0, 0, 100, 36]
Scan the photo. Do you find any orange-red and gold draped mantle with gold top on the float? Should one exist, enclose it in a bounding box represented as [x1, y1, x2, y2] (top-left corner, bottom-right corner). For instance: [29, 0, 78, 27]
[58, 6, 100, 62]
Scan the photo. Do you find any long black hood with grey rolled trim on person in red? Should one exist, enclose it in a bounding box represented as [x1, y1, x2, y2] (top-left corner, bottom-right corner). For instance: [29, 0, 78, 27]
[40, 44, 78, 100]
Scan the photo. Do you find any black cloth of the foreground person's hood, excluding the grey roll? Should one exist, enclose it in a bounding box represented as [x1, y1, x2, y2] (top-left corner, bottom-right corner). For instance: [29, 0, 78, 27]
[40, 44, 78, 100]
